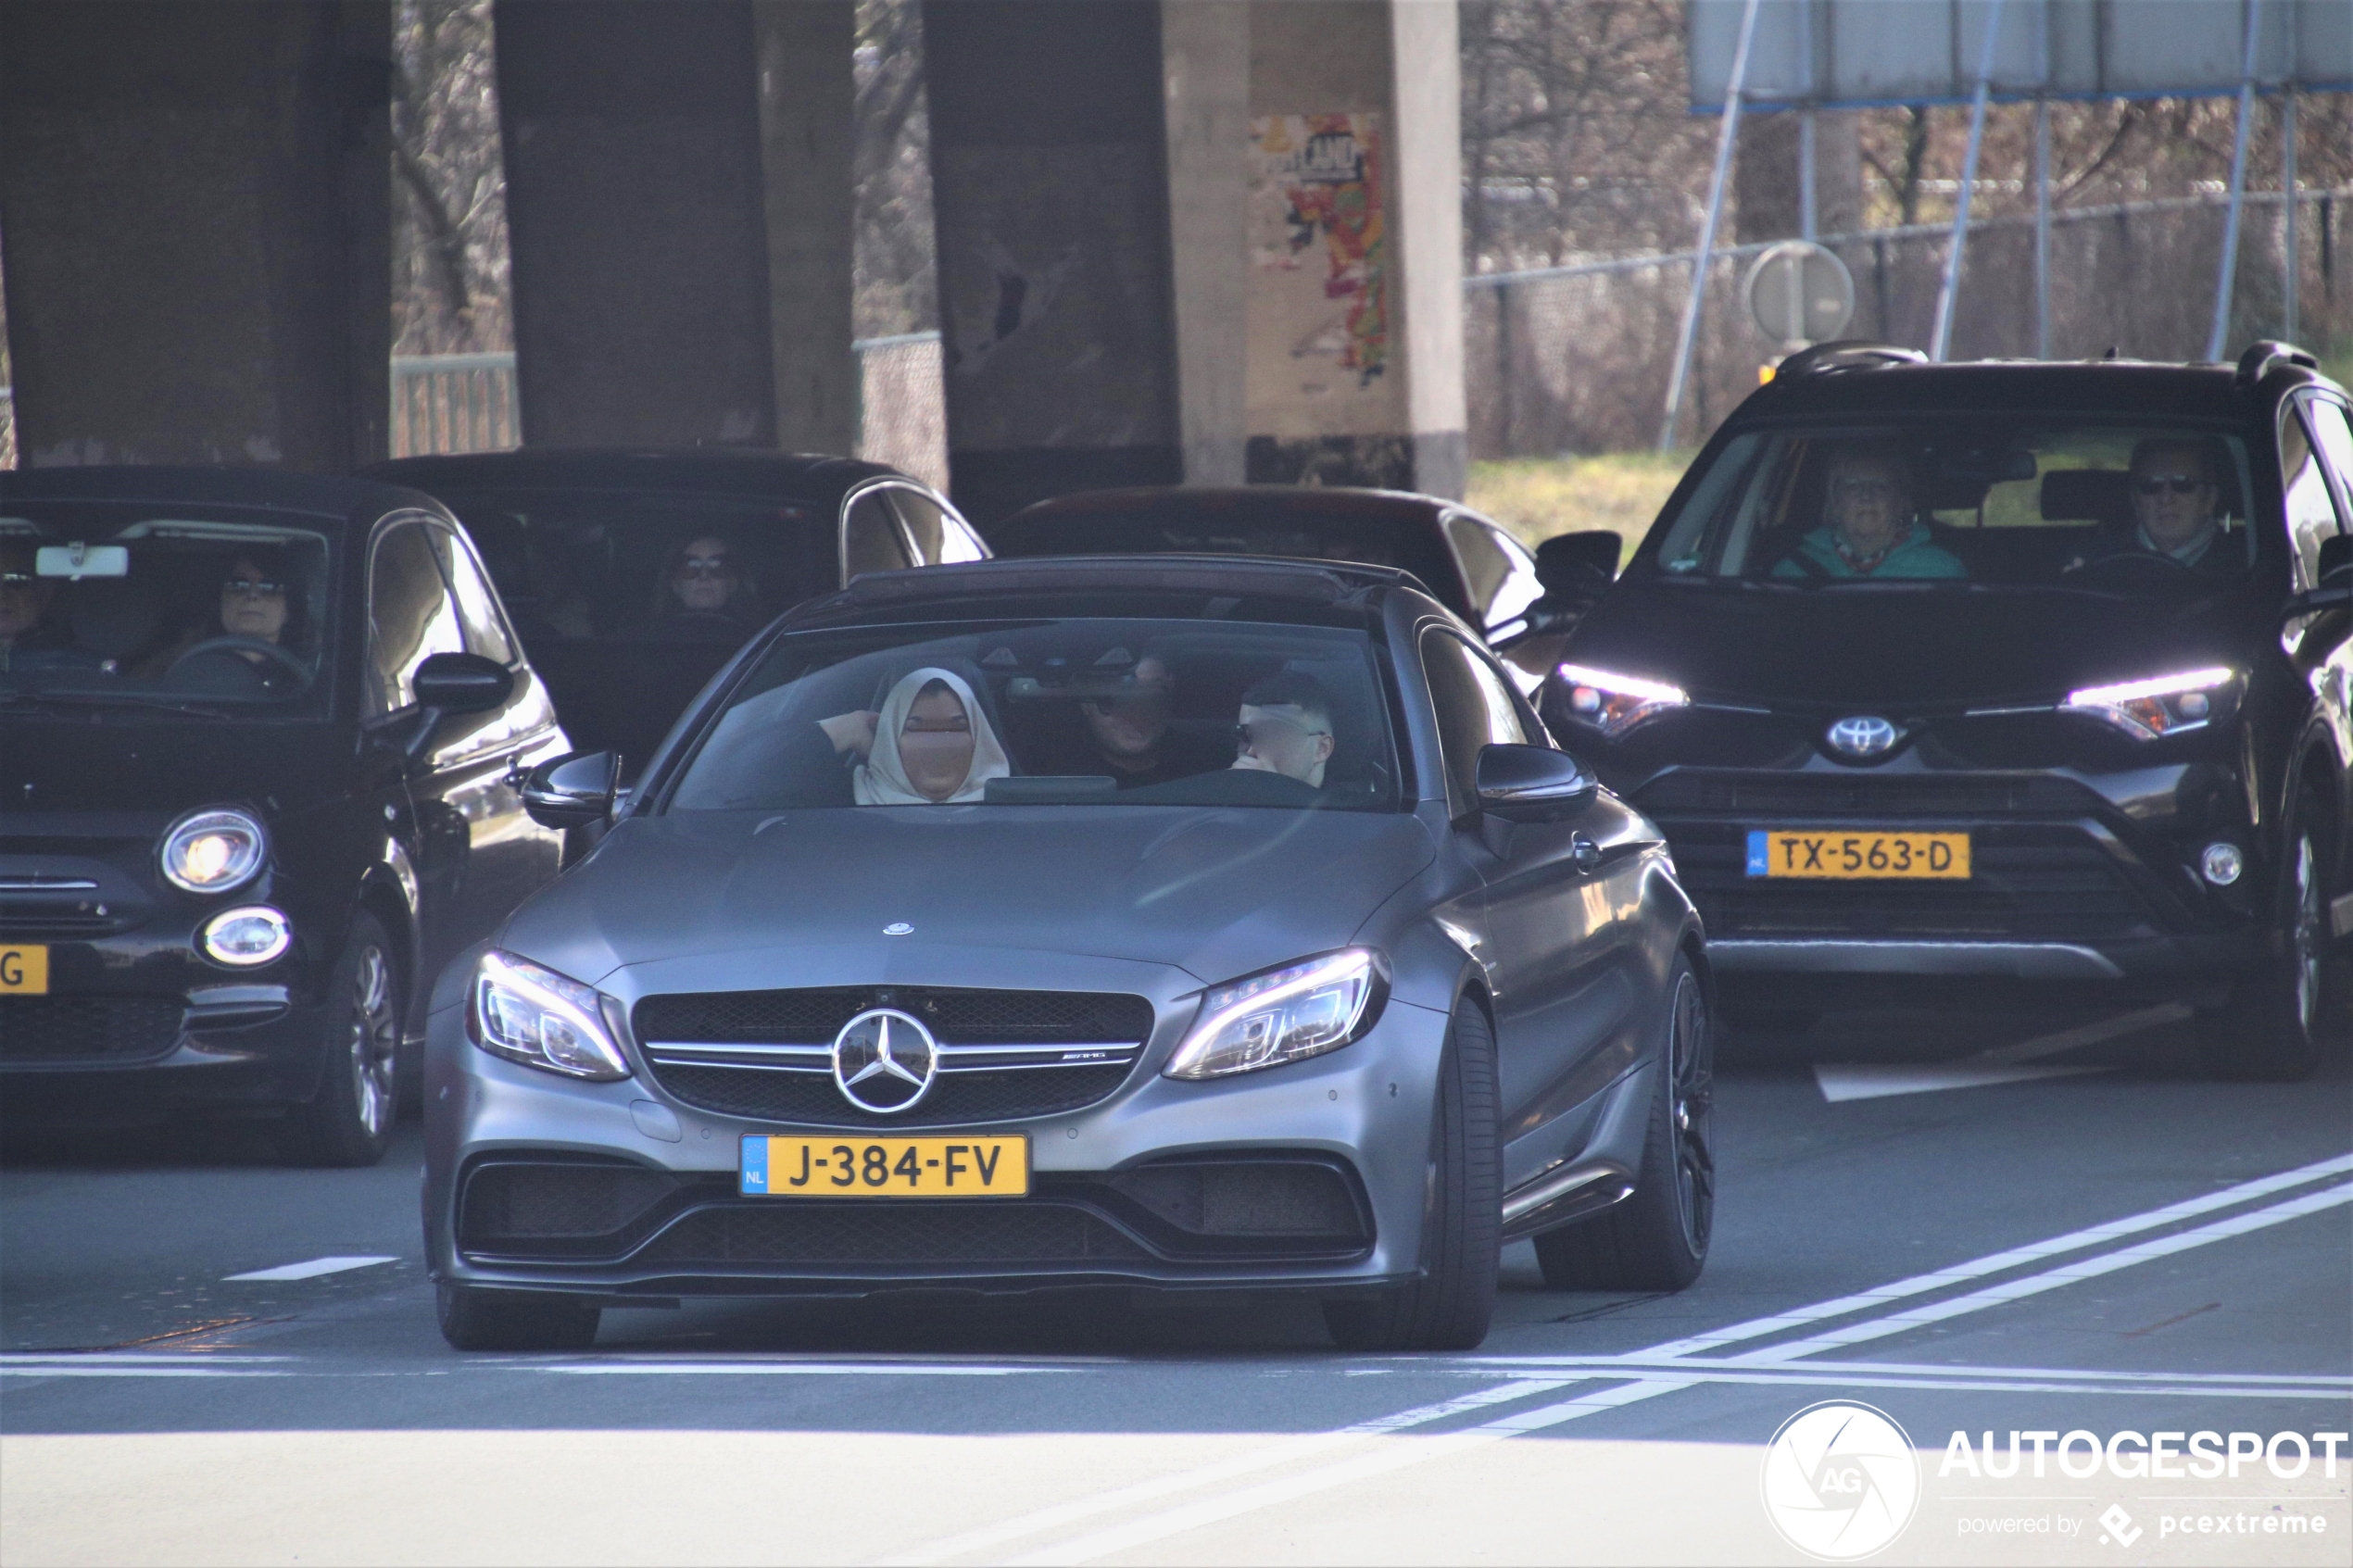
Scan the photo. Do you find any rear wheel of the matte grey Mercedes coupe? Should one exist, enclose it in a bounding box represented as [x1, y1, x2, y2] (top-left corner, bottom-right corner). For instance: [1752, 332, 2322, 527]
[1537, 957, 1716, 1290]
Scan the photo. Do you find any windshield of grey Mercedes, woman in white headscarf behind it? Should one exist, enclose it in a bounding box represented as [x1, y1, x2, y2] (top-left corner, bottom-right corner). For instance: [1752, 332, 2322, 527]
[671, 619, 1398, 811]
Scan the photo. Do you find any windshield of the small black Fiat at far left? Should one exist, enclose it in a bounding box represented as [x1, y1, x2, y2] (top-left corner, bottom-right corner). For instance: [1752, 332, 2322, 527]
[0, 503, 334, 720]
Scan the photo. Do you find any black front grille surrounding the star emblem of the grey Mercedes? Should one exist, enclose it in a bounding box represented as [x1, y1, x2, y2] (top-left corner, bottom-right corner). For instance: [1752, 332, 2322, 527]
[631, 985, 1153, 1128]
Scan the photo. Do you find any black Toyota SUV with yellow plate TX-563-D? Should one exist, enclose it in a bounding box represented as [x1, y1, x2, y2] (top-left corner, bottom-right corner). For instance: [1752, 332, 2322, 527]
[1543, 344, 2353, 1077]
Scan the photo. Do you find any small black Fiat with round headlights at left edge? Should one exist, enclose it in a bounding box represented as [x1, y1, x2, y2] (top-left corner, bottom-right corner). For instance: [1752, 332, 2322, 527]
[0, 468, 567, 1163]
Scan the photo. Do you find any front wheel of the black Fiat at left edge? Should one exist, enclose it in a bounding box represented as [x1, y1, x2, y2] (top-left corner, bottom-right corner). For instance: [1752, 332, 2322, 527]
[284, 909, 405, 1166]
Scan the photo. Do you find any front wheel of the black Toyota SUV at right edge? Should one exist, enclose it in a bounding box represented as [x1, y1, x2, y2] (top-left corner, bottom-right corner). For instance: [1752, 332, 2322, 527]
[2197, 804, 2336, 1084]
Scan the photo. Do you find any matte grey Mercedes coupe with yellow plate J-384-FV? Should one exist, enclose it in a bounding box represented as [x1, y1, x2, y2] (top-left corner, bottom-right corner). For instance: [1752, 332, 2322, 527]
[423, 558, 1713, 1349]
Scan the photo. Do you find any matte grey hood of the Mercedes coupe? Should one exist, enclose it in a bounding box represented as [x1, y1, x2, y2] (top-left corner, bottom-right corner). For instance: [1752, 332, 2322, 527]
[501, 807, 1435, 985]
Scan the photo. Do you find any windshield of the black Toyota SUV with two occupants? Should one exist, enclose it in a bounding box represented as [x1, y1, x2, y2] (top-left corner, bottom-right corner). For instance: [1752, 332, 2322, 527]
[1642, 416, 2257, 595]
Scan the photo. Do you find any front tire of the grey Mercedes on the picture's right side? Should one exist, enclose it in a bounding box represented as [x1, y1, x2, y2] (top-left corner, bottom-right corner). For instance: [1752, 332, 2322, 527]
[1322, 999, 1504, 1349]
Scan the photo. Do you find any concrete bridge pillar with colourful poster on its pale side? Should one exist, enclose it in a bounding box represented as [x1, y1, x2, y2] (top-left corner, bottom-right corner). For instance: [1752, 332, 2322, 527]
[925, 0, 1464, 524]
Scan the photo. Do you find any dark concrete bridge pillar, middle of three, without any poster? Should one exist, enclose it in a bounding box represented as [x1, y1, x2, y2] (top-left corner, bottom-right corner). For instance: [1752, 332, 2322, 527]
[494, 0, 857, 451]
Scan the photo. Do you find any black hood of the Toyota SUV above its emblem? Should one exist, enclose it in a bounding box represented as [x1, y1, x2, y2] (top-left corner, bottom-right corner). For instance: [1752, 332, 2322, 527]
[1563, 581, 2252, 710]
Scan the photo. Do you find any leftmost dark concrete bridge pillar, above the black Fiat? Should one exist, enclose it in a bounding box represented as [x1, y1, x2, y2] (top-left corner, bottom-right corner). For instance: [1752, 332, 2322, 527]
[0, 0, 391, 470]
